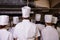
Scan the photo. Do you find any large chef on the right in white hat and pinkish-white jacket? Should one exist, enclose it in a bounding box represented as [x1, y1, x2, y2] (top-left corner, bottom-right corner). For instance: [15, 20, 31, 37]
[42, 14, 59, 40]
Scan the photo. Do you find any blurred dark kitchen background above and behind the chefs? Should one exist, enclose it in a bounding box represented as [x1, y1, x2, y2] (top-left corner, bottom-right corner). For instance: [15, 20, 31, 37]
[0, 0, 60, 27]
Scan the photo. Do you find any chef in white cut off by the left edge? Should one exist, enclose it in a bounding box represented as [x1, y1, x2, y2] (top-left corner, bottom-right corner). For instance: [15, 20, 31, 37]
[0, 15, 13, 40]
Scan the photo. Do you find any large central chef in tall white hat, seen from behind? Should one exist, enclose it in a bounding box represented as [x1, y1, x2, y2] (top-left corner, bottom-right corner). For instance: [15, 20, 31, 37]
[14, 6, 40, 40]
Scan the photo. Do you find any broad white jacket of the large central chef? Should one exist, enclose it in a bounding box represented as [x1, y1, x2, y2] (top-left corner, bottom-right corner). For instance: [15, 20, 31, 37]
[14, 19, 40, 40]
